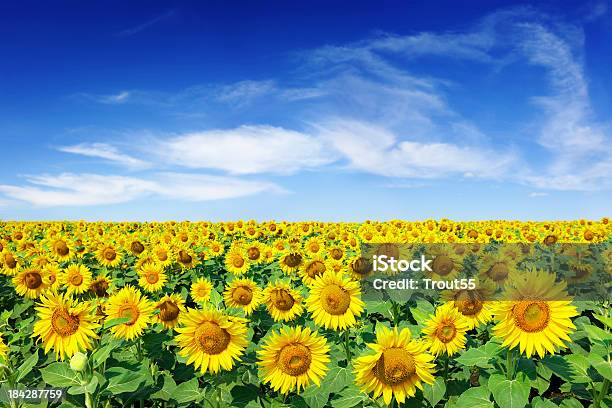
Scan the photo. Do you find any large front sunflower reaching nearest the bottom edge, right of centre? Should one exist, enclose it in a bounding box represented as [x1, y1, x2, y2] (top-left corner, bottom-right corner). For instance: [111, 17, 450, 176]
[354, 326, 435, 405]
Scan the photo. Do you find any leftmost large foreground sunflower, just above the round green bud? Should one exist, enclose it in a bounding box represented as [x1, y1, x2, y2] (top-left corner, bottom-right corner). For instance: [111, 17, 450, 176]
[33, 292, 99, 360]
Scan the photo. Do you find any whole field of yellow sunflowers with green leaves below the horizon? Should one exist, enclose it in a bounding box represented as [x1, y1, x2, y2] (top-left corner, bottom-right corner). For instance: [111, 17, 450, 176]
[0, 222, 612, 408]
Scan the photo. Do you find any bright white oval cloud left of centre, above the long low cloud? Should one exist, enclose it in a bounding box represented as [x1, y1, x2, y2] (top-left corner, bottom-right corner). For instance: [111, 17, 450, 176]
[155, 126, 333, 174]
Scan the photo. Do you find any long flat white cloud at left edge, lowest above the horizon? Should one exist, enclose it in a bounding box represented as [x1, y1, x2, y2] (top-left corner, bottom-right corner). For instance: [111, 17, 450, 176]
[0, 173, 284, 207]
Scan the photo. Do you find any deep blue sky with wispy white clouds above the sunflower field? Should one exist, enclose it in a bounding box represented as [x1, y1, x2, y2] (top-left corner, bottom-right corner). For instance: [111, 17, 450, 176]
[0, 1, 612, 221]
